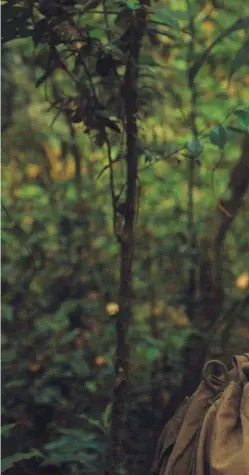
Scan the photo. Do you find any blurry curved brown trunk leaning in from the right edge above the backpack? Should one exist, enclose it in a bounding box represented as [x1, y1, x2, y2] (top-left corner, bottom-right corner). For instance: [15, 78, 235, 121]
[160, 134, 249, 432]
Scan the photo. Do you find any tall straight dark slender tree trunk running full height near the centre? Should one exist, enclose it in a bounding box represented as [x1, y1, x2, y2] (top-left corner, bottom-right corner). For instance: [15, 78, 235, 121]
[105, 0, 148, 475]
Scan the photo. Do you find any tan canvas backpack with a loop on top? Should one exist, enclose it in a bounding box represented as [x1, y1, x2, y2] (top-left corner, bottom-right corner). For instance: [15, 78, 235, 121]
[153, 353, 249, 475]
